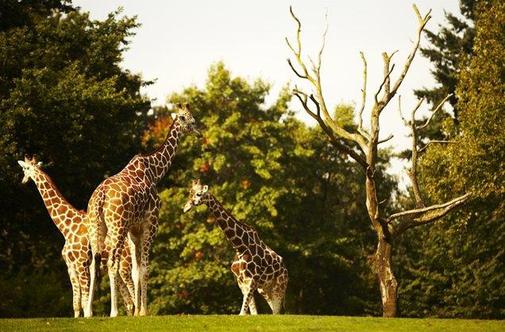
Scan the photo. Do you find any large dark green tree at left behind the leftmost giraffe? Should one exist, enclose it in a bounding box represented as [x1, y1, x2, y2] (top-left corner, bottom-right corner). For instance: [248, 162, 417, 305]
[0, 5, 150, 316]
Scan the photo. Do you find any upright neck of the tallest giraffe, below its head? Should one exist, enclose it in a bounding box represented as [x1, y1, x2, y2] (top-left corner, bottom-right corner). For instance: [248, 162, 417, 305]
[142, 119, 182, 183]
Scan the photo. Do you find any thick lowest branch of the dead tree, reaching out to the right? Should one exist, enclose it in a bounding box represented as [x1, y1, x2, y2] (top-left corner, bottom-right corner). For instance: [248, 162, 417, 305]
[387, 193, 471, 235]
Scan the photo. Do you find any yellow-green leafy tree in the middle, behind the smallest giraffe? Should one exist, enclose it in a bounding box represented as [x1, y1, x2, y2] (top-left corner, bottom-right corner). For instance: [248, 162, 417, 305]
[146, 63, 377, 314]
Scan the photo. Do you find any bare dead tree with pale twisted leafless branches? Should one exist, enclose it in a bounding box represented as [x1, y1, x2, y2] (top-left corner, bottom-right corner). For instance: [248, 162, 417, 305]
[286, 5, 470, 317]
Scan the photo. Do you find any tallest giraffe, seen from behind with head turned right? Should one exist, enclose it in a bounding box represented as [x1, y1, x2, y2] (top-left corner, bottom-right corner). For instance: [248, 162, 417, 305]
[86, 105, 198, 317]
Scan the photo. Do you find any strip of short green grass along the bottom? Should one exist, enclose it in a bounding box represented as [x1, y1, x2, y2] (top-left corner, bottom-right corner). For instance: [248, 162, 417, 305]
[0, 315, 505, 332]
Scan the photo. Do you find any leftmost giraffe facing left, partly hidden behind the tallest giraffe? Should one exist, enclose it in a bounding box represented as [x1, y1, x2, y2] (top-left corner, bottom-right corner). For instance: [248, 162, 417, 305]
[18, 157, 133, 318]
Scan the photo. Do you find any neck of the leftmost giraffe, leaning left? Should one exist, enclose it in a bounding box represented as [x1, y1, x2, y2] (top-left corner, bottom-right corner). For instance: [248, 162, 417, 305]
[33, 169, 80, 239]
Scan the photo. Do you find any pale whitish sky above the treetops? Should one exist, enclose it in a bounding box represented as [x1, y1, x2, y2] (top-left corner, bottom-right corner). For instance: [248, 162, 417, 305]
[73, 0, 459, 180]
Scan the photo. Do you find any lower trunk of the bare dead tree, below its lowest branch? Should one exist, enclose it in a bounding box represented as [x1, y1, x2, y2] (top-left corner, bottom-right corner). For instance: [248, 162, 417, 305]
[375, 236, 398, 317]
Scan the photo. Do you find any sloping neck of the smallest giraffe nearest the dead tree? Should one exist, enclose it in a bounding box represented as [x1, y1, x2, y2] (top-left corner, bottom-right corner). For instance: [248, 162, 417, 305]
[202, 193, 253, 252]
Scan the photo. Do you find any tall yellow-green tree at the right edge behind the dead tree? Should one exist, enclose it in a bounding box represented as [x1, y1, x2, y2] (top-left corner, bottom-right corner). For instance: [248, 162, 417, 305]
[402, 1, 505, 318]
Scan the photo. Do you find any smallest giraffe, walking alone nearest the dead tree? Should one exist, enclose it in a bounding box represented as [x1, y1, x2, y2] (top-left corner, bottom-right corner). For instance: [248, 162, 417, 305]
[184, 180, 288, 315]
